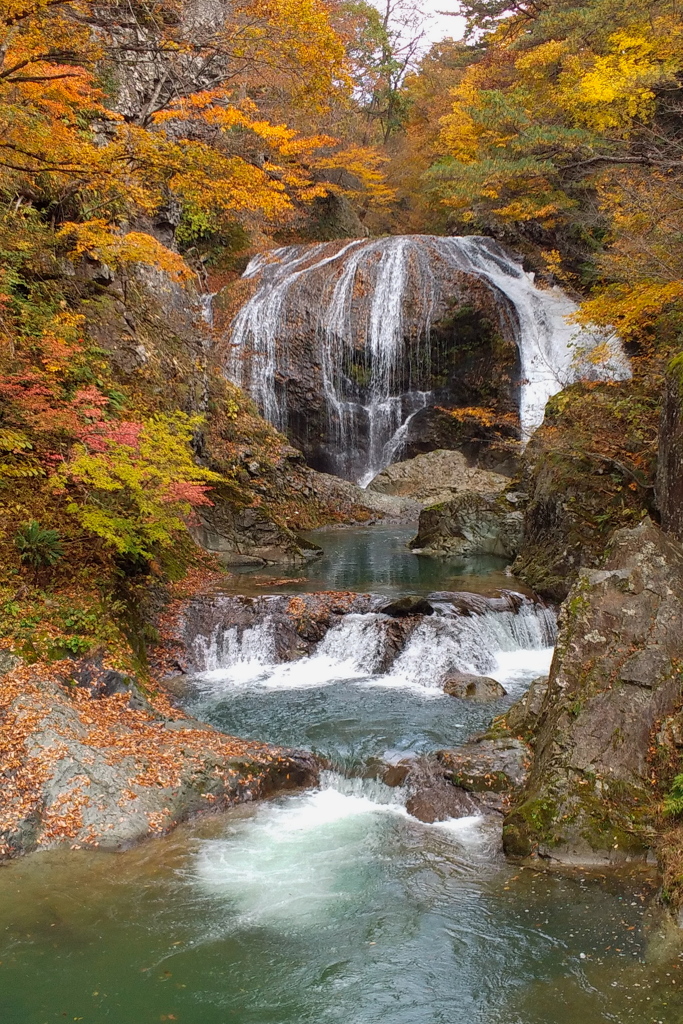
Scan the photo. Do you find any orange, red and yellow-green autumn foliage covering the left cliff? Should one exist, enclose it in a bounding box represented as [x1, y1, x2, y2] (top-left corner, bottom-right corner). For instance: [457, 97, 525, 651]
[0, 0, 395, 585]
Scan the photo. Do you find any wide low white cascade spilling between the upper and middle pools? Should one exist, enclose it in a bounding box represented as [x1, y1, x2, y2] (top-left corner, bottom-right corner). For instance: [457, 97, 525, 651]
[189, 599, 556, 695]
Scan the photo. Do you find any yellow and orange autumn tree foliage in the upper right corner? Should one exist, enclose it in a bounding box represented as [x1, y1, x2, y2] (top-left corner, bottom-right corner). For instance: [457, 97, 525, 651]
[428, 0, 683, 339]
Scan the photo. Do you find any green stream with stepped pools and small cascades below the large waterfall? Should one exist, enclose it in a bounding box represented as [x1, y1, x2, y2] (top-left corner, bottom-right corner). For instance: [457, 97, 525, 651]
[0, 528, 683, 1024]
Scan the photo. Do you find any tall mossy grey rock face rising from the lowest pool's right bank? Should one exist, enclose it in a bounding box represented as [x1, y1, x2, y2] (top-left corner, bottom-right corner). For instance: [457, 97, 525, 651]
[505, 519, 683, 864]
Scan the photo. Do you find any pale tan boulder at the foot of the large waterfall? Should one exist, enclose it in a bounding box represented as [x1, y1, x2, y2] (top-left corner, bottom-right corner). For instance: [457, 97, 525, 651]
[368, 450, 510, 505]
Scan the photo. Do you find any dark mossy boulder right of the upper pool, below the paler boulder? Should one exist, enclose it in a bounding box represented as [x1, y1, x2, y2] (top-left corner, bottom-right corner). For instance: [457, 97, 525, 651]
[411, 492, 523, 559]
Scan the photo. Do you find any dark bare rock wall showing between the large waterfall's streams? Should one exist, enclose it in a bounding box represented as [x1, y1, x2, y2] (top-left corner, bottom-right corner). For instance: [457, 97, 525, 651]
[218, 238, 519, 479]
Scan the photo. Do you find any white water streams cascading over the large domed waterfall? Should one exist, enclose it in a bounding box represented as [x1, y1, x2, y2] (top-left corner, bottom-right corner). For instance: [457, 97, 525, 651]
[227, 236, 628, 483]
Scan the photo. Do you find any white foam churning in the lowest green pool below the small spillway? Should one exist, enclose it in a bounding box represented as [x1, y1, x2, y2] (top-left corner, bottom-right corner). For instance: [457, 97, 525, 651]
[193, 772, 497, 932]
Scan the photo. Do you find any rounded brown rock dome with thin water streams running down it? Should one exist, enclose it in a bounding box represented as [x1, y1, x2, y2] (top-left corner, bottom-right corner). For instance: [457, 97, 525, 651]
[225, 236, 520, 480]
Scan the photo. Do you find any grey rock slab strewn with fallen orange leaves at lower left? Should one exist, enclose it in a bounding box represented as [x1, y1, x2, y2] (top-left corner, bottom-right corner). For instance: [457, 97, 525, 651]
[0, 669, 319, 857]
